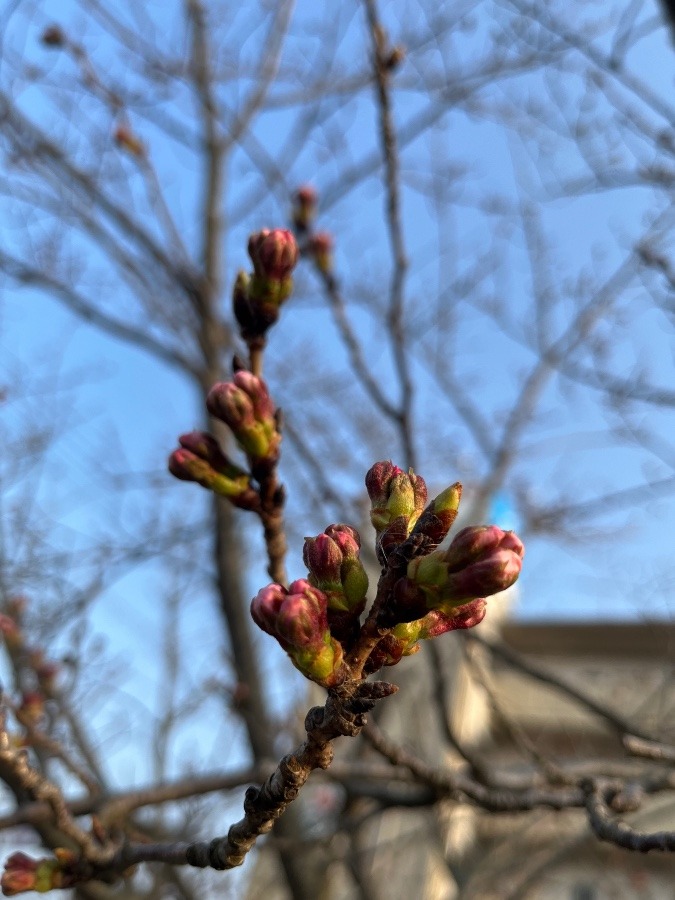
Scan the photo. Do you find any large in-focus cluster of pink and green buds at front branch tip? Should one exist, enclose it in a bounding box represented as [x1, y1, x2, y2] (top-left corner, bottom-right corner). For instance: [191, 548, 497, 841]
[251, 461, 525, 687]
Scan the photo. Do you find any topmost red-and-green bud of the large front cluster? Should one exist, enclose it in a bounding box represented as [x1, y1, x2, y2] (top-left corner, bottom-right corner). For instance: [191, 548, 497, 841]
[366, 461, 427, 532]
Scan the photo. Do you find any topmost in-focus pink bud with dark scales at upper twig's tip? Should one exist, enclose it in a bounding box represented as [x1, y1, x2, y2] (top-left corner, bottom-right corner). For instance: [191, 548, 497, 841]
[232, 228, 299, 347]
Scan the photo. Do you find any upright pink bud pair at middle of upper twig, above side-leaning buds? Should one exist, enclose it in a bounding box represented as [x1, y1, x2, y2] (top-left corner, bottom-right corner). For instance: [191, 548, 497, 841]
[206, 369, 281, 462]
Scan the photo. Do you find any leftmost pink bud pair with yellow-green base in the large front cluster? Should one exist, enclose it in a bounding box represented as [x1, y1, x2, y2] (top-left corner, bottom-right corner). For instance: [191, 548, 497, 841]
[251, 579, 343, 687]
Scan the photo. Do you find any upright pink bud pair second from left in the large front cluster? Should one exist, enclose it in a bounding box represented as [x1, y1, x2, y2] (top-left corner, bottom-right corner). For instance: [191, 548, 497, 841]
[302, 525, 368, 649]
